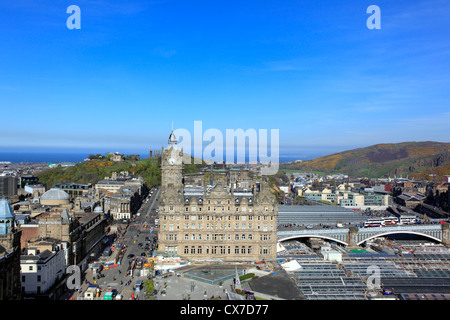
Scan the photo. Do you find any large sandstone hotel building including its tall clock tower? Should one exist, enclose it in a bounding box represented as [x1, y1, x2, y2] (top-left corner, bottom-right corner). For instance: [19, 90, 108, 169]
[158, 132, 278, 261]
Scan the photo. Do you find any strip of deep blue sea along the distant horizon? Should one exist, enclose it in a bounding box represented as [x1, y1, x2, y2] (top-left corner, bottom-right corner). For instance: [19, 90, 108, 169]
[0, 152, 308, 163]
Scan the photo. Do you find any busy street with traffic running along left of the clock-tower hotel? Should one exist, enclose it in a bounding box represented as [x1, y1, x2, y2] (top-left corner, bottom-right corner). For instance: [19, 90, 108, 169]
[72, 188, 161, 300]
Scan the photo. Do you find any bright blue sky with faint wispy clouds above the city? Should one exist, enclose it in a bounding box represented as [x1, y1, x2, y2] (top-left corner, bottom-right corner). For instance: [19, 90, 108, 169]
[0, 0, 450, 157]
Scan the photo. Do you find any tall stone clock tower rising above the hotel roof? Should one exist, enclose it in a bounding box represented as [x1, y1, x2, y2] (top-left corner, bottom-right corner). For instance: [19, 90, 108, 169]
[161, 130, 183, 198]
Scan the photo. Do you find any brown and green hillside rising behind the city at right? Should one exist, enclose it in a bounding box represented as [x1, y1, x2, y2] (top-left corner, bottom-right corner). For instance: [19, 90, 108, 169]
[282, 141, 450, 180]
